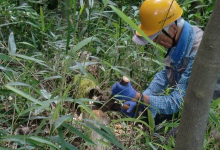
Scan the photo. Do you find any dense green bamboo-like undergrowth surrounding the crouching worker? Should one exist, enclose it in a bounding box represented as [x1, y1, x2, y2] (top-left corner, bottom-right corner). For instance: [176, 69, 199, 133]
[0, 0, 220, 149]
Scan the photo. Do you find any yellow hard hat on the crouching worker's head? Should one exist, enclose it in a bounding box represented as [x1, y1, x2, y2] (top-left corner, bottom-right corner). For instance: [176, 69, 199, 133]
[136, 0, 183, 36]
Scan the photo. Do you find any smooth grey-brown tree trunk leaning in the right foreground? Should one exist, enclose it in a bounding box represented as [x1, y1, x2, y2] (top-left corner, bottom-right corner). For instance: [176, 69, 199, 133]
[175, 0, 220, 150]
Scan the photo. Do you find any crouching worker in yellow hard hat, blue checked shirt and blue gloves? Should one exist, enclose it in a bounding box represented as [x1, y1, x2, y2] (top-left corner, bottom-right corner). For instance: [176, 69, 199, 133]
[112, 0, 203, 124]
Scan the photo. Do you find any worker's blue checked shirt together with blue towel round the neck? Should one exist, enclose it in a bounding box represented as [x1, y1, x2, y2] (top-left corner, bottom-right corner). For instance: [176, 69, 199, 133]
[143, 21, 203, 117]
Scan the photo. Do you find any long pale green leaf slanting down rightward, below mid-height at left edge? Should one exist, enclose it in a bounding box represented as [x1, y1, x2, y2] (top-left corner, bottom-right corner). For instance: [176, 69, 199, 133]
[5, 85, 48, 108]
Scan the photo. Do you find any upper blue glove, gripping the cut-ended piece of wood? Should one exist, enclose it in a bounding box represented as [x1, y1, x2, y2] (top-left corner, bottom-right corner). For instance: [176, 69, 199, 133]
[112, 82, 136, 101]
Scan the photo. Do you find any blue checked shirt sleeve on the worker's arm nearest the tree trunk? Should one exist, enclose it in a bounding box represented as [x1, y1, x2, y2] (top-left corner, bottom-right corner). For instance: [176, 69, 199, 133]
[146, 57, 194, 117]
